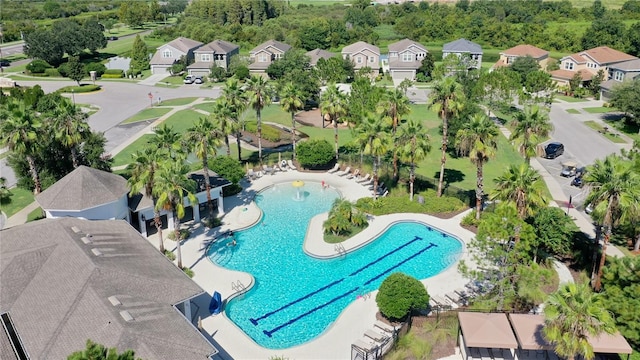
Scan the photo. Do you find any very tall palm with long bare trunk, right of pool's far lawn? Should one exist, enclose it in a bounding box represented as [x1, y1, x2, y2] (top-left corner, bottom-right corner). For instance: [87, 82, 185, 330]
[429, 76, 464, 196]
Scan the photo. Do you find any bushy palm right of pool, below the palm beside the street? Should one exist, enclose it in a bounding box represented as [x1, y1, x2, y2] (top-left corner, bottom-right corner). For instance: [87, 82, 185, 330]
[491, 163, 547, 242]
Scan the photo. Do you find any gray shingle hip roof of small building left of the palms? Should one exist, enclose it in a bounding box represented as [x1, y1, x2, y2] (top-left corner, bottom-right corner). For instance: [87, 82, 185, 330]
[36, 166, 128, 210]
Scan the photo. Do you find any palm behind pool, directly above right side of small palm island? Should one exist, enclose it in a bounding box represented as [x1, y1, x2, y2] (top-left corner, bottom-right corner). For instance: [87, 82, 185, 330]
[356, 113, 391, 199]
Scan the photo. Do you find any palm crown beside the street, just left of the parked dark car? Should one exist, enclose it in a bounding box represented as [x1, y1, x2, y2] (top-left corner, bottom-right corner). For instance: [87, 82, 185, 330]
[509, 105, 552, 164]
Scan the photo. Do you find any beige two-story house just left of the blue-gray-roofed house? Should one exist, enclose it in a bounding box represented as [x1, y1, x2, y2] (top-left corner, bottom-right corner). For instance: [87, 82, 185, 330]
[388, 39, 427, 83]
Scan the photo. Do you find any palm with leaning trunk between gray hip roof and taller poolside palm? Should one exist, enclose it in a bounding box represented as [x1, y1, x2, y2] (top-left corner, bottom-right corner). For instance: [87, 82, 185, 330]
[127, 146, 168, 254]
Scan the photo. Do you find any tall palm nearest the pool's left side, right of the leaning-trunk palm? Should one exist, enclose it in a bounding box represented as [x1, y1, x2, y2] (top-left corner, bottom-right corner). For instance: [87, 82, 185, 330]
[153, 158, 198, 269]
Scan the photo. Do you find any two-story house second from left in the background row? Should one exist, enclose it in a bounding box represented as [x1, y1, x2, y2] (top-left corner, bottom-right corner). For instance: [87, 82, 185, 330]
[187, 40, 240, 75]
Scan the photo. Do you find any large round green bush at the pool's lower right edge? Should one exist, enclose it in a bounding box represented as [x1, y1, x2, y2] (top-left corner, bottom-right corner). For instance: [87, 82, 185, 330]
[376, 273, 429, 320]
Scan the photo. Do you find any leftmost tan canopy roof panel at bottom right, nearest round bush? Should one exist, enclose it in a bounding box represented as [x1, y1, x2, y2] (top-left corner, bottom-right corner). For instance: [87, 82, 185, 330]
[458, 312, 518, 349]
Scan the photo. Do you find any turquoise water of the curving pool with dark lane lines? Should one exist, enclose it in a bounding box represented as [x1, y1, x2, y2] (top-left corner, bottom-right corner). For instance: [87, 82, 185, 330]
[207, 182, 462, 349]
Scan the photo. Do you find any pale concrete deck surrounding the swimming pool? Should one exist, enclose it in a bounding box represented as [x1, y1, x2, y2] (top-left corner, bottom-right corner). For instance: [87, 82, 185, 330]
[149, 170, 474, 360]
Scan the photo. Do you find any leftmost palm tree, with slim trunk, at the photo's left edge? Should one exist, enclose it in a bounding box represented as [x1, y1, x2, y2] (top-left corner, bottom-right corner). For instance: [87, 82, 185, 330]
[0, 104, 42, 195]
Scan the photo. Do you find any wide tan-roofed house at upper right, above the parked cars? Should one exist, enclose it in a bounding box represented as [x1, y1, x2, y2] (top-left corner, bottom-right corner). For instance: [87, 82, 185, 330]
[551, 46, 637, 86]
